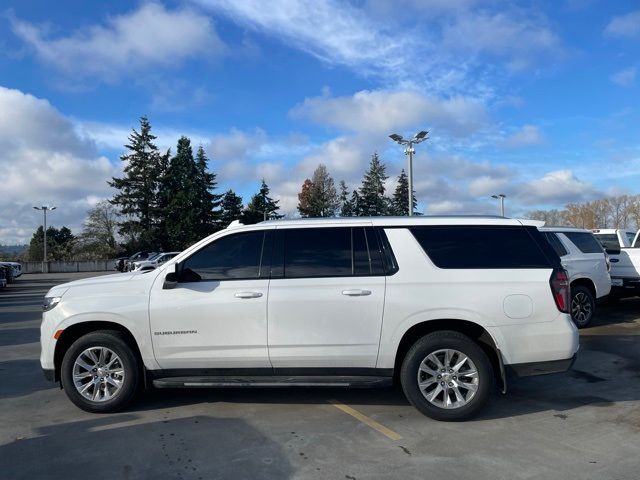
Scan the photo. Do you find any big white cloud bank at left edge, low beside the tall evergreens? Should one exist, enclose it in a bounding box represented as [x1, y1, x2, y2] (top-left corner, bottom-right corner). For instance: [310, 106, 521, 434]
[0, 87, 119, 243]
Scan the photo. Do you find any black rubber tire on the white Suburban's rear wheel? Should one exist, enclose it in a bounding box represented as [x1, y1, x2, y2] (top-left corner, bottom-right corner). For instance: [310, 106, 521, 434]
[400, 330, 495, 421]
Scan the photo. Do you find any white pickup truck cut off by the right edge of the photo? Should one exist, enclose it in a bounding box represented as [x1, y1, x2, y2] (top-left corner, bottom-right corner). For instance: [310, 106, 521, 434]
[593, 228, 640, 298]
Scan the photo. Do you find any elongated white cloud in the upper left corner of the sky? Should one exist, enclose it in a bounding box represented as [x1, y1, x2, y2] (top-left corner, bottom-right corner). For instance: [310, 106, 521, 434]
[11, 3, 225, 81]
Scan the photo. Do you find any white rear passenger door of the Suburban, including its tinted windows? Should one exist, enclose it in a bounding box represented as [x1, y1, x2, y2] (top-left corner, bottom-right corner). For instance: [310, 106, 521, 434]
[268, 227, 385, 373]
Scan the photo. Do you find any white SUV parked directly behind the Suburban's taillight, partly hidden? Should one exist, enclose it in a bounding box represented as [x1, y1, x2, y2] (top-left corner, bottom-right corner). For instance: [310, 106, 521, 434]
[539, 227, 611, 328]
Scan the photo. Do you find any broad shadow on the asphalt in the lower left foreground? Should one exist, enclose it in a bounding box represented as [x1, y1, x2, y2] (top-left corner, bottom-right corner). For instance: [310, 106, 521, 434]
[0, 414, 293, 480]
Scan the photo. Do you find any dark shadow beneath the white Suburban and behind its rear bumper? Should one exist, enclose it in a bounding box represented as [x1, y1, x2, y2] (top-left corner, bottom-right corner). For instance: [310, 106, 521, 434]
[131, 335, 640, 420]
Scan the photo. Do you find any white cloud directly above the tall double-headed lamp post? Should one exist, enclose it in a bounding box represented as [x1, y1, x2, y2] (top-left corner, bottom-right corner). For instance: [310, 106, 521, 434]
[291, 90, 488, 136]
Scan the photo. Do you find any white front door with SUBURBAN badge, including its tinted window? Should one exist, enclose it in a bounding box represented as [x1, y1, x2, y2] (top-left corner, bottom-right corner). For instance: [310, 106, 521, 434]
[149, 230, 271, 373]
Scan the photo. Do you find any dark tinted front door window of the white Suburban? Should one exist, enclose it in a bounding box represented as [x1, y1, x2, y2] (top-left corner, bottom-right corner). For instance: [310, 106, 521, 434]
[181, 231, 265, 281]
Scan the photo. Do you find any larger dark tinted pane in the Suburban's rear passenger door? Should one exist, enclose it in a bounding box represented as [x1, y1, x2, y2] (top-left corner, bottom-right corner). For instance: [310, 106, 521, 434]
[282, 228, 353, 278]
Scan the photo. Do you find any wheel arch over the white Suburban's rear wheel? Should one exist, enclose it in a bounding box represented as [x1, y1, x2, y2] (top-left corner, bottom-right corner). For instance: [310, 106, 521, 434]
[393, 319, 507, 393]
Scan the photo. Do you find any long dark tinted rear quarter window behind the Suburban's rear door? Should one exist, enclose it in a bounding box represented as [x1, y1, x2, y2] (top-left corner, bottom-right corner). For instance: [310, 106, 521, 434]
[411, 226, 557, 268]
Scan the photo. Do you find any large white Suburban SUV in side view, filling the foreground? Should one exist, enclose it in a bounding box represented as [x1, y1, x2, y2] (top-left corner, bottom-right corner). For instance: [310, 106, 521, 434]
[40, 217, 578, 420]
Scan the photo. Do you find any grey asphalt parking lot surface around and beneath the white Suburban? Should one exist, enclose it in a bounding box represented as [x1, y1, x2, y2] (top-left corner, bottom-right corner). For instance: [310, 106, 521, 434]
[0, 274, 640, 480]
